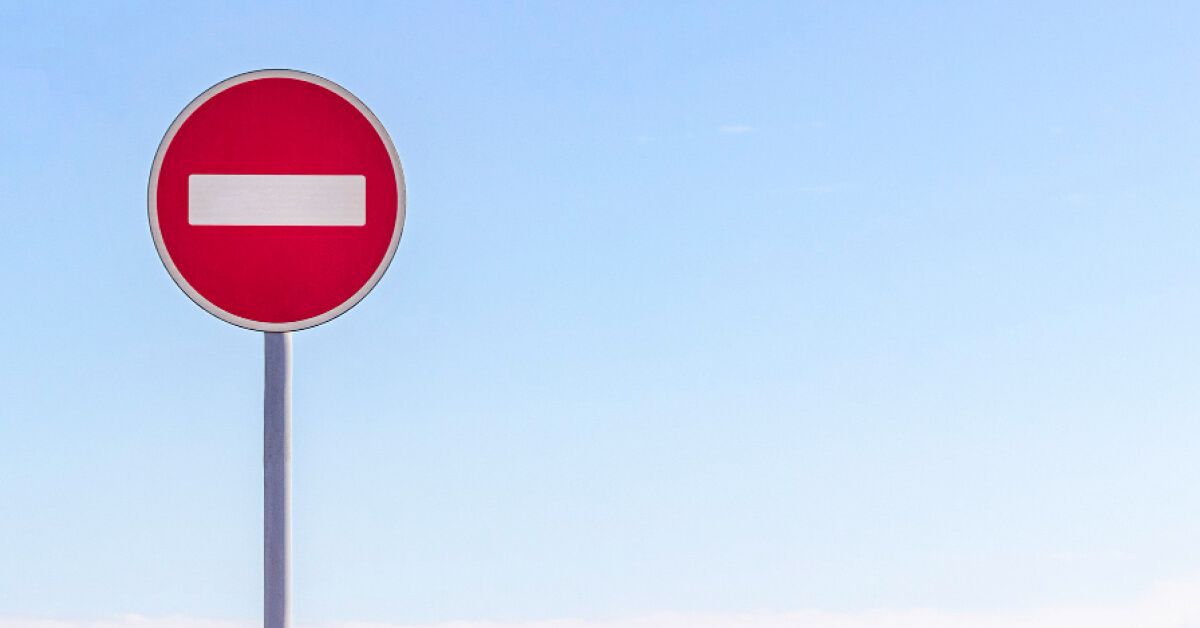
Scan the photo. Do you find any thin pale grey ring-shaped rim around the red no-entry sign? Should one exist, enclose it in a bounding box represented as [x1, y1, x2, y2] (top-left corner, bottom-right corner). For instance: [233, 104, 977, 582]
[146, 70, 407, 331]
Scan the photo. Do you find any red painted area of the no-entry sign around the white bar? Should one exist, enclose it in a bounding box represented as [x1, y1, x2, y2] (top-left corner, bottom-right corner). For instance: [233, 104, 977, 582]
[155, 78, 398, 323]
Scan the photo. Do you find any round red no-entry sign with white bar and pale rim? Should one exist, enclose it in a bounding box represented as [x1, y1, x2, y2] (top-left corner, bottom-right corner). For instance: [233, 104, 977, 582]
[149, 70, 404, 331]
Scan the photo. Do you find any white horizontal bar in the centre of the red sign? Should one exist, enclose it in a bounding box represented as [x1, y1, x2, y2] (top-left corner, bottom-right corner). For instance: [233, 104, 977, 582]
[187, 174, 367, 227]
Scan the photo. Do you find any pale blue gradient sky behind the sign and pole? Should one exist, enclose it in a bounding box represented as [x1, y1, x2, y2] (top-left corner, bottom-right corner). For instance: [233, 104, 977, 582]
[0, 2, 1200, 623]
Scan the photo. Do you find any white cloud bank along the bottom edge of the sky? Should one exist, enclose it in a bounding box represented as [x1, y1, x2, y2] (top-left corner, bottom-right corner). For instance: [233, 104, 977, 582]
[11, 578, 1200, 628]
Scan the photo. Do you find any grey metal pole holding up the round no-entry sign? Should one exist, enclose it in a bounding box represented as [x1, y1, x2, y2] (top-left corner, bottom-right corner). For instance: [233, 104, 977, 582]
[263, 333, 292, 628]
